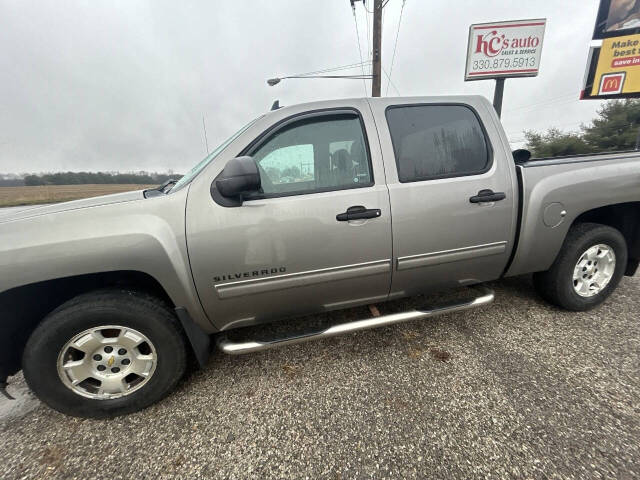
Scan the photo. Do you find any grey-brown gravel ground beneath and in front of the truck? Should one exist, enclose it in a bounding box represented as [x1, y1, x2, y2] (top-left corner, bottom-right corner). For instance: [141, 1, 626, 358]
[0, 276, 640, 480]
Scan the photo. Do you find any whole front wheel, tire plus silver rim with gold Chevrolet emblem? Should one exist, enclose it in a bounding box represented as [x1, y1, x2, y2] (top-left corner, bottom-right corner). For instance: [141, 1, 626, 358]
[23, 290, 186, 418]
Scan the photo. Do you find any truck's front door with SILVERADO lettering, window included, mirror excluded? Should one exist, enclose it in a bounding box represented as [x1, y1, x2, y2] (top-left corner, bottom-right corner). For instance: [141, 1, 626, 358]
[187, 100, 391, 329]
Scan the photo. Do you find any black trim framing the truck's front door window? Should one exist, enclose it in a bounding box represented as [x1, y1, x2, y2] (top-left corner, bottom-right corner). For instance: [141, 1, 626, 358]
[238, 107, 375, 201]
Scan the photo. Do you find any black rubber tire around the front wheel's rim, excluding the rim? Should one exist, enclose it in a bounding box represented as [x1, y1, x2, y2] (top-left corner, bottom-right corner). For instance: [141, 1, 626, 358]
[22, 289, 187, 418]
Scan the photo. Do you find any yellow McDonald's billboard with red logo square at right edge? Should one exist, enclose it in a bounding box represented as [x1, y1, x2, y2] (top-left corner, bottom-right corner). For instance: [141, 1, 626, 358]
[589, 34, 640, 98]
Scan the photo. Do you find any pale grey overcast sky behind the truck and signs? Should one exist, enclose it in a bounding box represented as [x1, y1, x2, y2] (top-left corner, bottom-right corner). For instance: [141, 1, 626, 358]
[0, 0, 599, 172]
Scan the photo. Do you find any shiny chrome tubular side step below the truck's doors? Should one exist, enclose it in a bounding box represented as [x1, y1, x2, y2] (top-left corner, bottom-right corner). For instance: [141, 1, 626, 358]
[217, 286, 495, 355]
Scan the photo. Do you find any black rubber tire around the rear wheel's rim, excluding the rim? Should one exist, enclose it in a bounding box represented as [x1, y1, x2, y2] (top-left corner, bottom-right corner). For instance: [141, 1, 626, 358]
[533, 223, 628, 312]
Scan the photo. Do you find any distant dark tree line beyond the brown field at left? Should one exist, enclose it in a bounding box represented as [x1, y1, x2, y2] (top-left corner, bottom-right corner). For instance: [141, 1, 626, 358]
[24, 172, 182, 186]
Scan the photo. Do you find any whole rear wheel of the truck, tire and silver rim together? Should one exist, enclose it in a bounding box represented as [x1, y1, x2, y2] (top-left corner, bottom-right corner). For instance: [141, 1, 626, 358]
[533, 223, 628, 311]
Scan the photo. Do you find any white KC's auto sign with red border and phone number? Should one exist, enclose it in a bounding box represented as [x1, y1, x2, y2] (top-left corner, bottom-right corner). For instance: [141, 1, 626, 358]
[464, 19, 547, 80]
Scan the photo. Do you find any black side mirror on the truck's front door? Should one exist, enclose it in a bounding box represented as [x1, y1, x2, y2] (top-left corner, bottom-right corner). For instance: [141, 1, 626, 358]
[211, 157, 260, 207]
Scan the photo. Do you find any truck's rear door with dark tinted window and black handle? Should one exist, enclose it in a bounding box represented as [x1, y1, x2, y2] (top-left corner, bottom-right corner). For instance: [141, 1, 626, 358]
[371, 99, 517, 298]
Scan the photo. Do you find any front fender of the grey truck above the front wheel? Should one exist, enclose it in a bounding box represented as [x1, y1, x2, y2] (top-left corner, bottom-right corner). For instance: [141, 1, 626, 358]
[0, 189, 213, 331]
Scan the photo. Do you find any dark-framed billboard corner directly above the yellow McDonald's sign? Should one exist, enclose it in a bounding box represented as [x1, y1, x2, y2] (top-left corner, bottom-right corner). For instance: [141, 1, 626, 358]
[593, 0, 640, 40]
